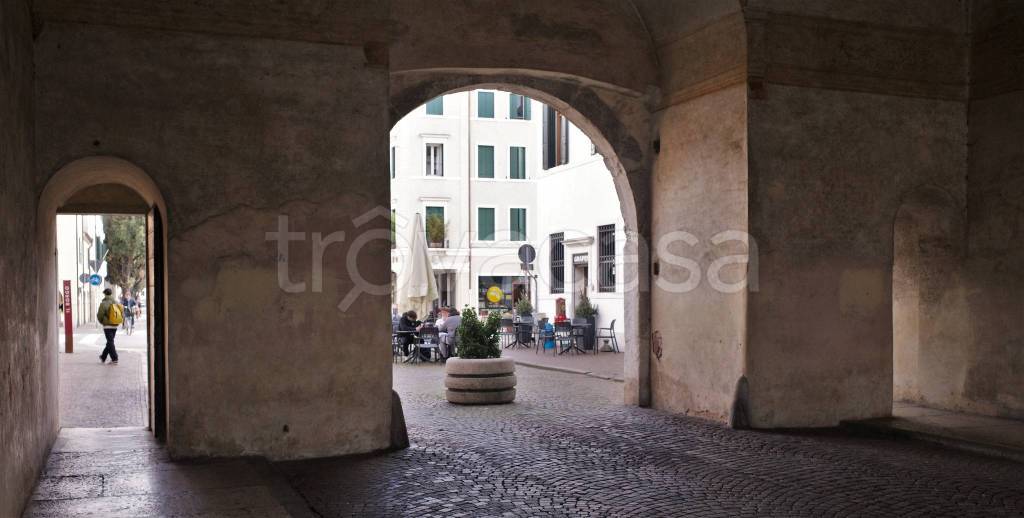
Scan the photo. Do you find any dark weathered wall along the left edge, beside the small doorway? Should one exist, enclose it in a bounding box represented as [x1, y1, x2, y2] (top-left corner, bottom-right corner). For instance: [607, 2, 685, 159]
[0, 0, 58, 516]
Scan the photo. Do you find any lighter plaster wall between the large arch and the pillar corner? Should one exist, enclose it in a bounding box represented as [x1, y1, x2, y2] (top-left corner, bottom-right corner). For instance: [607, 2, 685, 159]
[651, 84, 748, 420]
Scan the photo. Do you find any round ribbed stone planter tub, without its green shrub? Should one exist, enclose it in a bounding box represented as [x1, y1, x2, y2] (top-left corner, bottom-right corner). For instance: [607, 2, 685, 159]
[444, 358, 515, 404]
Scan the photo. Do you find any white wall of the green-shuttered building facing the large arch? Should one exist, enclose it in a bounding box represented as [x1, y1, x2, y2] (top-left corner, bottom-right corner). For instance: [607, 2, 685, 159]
[391, 90, 543, 312]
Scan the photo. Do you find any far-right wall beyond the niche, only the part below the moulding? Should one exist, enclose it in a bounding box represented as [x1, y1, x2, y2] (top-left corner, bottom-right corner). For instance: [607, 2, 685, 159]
[958, 89, 1024, 419]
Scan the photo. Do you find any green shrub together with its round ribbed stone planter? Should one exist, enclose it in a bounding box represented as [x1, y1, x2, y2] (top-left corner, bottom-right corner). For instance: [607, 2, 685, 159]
[444, 306, 516, 404]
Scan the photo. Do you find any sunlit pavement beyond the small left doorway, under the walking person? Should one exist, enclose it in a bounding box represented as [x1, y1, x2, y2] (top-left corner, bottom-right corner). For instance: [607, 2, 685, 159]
[59, 323, 150, 428]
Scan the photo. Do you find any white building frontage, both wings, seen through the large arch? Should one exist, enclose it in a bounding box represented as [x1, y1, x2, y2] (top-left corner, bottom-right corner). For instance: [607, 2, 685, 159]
[389, 90, 625, 347]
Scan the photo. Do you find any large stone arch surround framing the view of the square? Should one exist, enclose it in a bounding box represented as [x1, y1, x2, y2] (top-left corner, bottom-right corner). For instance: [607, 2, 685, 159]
[389, 70, 652, 406]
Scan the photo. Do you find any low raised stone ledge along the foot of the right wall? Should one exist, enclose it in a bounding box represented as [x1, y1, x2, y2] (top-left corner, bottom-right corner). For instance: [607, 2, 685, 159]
[844, 402, 1024, 462]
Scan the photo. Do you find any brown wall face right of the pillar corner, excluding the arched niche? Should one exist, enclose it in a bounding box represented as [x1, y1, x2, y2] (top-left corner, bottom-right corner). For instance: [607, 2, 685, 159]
[748, 2, 967, 427]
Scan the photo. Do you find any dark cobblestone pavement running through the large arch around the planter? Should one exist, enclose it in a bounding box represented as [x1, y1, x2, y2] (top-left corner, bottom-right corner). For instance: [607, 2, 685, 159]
[275, 364, 1024, 517]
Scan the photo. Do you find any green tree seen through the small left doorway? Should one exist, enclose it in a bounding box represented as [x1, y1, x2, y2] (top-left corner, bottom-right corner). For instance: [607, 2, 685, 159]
[103, 216, 145, 294]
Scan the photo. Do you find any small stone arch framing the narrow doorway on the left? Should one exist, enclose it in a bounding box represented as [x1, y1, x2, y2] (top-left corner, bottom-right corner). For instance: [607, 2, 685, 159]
[36, 157, 169, 440]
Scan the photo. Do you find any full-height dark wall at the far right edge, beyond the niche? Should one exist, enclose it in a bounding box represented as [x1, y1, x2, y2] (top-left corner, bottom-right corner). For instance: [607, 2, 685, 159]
[954, 0, 1024, 419]
